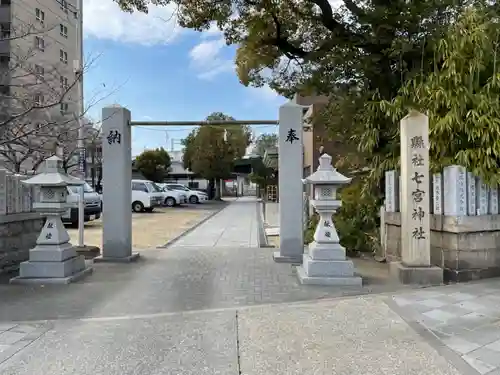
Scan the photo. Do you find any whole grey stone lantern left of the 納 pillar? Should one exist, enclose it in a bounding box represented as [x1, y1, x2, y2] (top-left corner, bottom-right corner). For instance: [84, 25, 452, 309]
[10, 156, 92, 284]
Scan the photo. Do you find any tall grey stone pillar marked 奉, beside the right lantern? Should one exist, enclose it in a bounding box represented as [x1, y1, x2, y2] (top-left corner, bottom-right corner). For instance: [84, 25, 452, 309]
[274, 102, 304, 263]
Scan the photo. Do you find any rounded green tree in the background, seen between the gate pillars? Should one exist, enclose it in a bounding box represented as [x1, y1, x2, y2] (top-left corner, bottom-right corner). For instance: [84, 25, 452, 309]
[183, 112, 251, 199]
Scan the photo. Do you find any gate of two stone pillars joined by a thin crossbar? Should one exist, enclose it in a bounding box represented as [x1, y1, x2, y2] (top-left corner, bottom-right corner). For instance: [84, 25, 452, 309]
[96, 102, 307, 263]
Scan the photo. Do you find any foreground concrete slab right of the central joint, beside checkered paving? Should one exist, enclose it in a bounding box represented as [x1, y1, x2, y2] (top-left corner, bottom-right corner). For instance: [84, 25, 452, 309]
[238, 297, 460, 375]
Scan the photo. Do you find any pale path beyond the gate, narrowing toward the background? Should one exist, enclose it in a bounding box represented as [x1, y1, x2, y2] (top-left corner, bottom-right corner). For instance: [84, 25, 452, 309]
[173, 197, 258, 248]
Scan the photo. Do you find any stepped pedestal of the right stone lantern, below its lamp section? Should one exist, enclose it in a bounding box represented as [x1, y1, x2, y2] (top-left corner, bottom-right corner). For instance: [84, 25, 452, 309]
[297, 200, 362, 286]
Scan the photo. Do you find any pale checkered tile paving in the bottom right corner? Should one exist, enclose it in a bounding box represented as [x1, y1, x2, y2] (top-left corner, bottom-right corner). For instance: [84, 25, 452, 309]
[392, 279, 500, 375]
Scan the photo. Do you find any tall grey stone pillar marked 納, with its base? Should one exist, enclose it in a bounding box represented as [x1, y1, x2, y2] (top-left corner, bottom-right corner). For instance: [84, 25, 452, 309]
[95, 105, 139, 262]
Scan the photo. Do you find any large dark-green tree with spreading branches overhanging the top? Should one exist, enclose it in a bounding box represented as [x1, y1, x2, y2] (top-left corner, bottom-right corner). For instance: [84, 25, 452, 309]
[115, 0, 468, 184]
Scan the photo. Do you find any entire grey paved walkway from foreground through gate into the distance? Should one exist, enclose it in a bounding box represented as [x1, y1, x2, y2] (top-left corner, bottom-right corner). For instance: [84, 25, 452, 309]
[0, 199, 500, 375]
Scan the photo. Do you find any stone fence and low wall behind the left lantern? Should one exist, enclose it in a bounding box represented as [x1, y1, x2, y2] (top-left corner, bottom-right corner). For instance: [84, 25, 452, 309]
[0, 169, 43, 273]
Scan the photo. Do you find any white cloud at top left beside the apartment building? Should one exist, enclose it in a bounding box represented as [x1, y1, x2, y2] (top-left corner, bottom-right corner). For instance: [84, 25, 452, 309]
[83, 0, 182, 45]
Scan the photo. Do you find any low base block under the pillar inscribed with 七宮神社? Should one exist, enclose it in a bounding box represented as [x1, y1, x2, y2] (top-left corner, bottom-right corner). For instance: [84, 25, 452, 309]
[389, 262, 443, 285]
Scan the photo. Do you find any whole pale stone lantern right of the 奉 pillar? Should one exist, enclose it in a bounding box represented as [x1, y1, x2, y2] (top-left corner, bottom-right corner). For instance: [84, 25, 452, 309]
[297, 154, 362, 286]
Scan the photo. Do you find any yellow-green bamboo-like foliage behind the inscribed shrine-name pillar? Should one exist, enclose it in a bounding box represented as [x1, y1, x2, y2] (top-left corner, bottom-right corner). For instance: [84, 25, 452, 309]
[376, 7, 500, 185]
